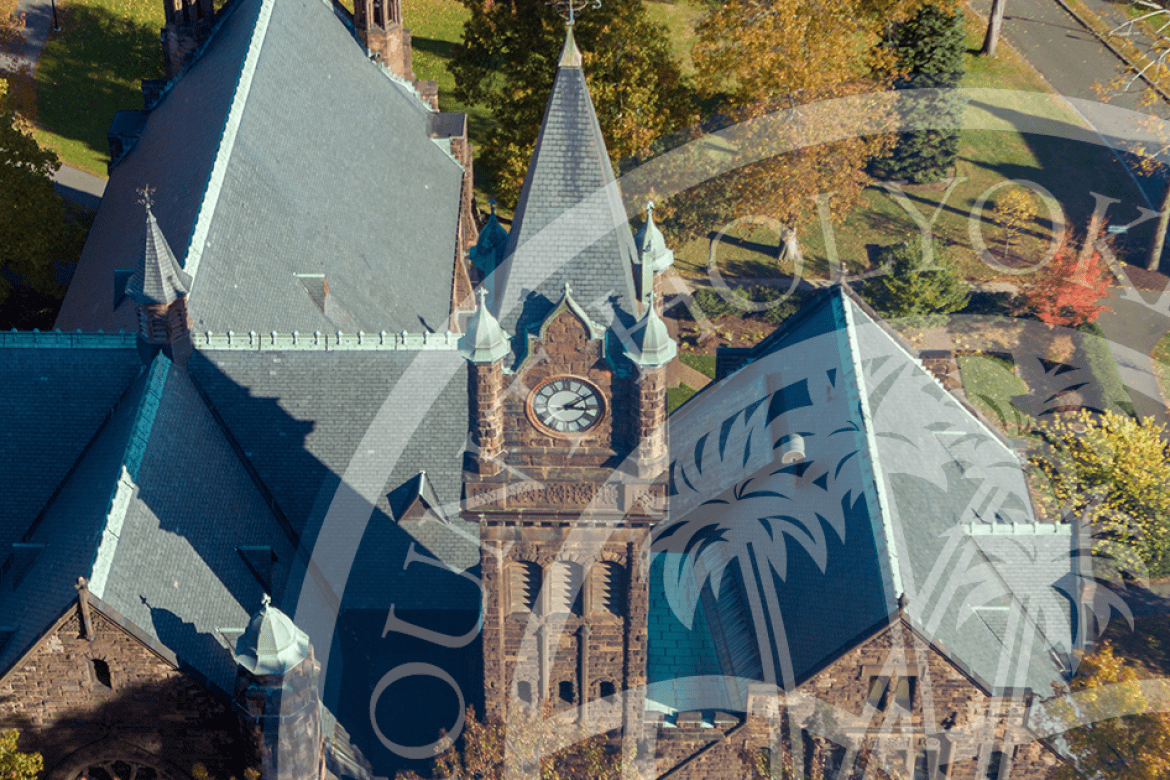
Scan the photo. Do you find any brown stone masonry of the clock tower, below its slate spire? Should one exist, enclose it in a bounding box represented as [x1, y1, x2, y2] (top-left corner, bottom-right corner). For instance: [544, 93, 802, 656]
[464, 305, 665, 723]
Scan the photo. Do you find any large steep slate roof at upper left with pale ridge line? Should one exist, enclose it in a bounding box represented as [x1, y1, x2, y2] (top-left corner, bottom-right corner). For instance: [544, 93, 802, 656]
[57, 0, 462, 333]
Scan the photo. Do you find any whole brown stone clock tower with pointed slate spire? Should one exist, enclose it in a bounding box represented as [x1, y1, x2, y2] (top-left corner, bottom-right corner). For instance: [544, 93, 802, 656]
[460, 32, 676, 747]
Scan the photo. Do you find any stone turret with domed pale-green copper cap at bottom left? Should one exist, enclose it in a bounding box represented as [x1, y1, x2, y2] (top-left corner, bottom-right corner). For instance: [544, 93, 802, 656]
[234, 594, 324, 780]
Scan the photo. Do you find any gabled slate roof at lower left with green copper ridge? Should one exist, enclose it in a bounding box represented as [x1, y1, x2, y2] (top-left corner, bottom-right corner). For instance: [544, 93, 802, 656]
[0, 356, 293, 691]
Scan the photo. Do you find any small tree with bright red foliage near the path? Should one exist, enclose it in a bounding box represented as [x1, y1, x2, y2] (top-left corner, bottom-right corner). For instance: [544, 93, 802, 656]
[1021, 246, 1113, 327]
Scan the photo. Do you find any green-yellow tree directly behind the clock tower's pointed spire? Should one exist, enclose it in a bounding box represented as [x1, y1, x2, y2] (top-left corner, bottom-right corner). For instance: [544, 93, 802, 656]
[448, 0, 694, 208]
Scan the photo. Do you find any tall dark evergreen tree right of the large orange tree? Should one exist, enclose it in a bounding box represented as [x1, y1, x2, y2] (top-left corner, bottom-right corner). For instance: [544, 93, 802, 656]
[872, 5, 966, 184]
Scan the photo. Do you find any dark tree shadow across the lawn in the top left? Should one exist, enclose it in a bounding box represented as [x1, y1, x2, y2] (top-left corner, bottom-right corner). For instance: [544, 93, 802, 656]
[36, 5, 163, 163]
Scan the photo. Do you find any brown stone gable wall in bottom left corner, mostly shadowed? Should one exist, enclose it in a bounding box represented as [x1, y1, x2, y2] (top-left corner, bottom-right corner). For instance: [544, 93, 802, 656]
[0, 608, 242, 780]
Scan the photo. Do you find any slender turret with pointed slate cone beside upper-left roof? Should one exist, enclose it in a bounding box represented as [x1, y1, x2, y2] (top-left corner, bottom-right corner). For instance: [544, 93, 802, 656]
[126, 202, 192, 365]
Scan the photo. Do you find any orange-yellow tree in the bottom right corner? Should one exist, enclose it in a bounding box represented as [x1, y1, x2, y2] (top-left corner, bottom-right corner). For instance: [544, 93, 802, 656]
[1045, 642, 1170, 780]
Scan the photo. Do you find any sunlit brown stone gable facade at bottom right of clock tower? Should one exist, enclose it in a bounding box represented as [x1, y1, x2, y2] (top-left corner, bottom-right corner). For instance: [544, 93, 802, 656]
[647, 619, 1059, 780]
